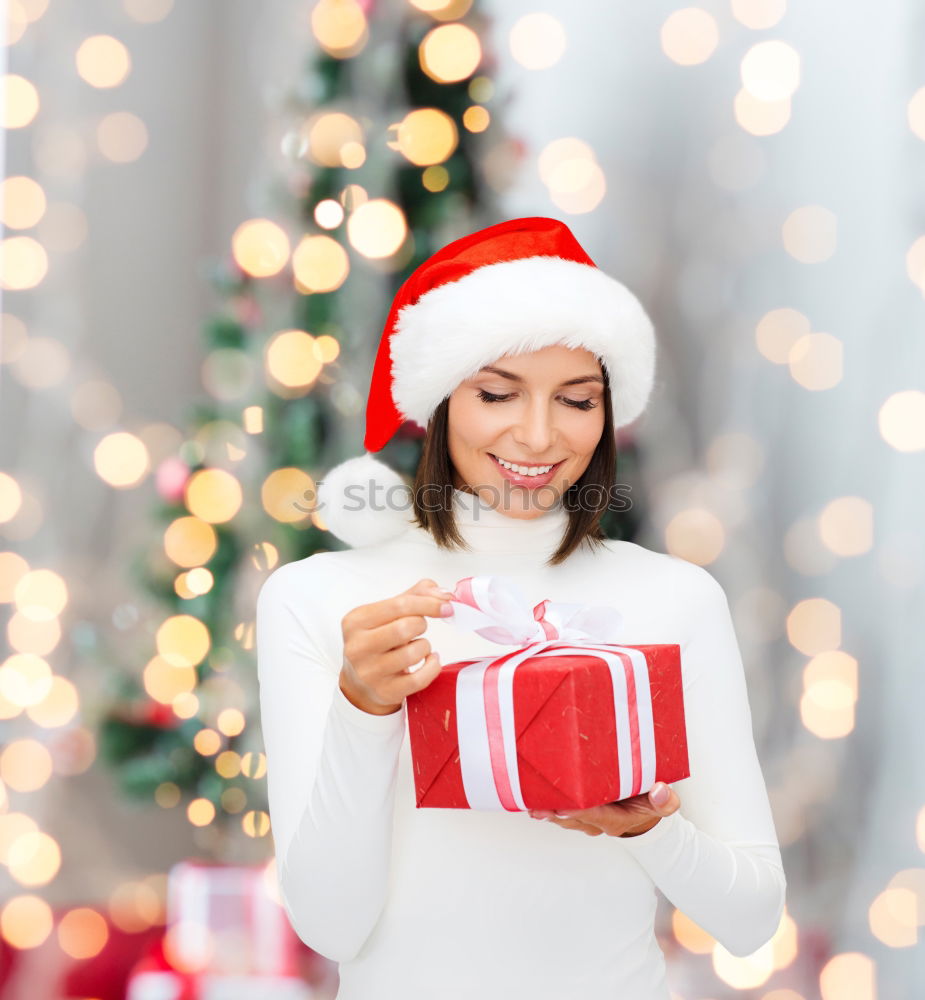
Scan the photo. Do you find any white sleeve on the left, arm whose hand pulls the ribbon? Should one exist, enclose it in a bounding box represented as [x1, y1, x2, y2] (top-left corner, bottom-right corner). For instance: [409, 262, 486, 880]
[256, 556, 406, 962]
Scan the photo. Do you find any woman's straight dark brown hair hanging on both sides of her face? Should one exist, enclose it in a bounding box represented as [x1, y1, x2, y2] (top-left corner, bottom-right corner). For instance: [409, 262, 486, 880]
[411, 362, 617, 566]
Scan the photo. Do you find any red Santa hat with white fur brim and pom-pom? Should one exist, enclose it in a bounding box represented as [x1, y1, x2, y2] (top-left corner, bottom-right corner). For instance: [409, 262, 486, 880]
[318, 216, 655, 546]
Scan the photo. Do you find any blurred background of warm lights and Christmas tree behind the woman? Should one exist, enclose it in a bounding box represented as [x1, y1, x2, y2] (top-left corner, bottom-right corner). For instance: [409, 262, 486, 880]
[0, 0, 925, 1000]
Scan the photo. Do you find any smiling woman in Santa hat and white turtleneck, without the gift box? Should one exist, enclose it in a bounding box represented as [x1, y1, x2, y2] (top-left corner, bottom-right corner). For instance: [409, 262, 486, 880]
[257, 218, 786, 1000]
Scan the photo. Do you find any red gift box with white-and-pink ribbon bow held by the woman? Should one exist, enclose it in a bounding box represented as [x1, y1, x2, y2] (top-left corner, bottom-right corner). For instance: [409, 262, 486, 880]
[406, 577, 690, 811]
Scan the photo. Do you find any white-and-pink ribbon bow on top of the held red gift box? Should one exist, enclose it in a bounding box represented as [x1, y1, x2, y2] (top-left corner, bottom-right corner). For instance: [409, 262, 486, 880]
[445, 576, 623, 646]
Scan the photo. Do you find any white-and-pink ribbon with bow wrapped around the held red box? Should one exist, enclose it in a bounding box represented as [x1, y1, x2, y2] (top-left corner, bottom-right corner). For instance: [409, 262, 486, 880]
[446, 576, 656, 811]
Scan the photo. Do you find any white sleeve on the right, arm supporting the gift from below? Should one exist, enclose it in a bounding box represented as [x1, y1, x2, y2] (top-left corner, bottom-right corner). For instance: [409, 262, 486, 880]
[620, 567, 786, 956]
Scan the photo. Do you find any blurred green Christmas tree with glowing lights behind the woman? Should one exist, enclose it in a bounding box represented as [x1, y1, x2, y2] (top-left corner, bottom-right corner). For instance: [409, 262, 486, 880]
[100, 0, 652, 837]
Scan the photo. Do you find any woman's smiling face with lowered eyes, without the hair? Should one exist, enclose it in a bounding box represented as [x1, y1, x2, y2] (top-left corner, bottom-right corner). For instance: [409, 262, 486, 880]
[447, 344, 605, 518]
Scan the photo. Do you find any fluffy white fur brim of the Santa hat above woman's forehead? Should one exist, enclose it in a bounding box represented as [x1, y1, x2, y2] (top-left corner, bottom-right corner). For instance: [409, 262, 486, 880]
[391, 256, 655, 427]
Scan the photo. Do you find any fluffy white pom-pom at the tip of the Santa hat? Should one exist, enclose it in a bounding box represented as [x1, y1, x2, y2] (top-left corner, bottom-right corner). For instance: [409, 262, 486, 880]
[316, 452, 414, 548]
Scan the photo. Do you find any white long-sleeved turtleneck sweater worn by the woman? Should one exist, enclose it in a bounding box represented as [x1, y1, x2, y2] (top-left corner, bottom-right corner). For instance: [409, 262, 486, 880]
[257, 490, 786, 1000]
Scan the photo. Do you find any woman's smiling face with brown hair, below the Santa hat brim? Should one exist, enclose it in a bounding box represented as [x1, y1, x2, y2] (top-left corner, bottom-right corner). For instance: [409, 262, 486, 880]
[412, 344, 617, 565]
